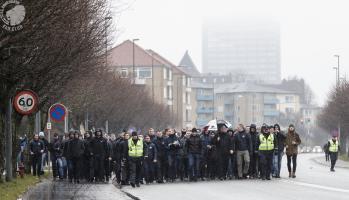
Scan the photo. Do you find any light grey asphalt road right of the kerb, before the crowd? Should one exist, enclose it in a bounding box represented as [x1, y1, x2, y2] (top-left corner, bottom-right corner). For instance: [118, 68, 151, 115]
[124, 154, 349, 200]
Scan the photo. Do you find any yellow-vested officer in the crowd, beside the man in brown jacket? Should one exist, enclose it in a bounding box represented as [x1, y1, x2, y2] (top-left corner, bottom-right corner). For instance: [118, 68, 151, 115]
[256, 124, 276, 180]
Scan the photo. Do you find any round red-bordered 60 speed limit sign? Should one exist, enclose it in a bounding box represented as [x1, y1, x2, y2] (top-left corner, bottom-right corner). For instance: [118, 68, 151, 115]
[13, 90, 38, 115]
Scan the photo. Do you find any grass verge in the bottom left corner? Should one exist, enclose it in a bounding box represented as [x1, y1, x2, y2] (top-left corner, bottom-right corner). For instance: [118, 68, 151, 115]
[0, 172, 50, 200]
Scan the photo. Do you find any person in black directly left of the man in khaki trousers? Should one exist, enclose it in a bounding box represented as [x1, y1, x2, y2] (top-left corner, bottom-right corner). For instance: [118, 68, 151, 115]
[212, 124, 234, 180]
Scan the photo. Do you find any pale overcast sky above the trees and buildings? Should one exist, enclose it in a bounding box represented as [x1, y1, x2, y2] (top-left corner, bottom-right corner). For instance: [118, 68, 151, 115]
[112, 0, 349, 105]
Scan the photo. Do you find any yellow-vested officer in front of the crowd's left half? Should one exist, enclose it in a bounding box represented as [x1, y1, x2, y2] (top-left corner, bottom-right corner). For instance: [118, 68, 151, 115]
[127, 131, 148, 188]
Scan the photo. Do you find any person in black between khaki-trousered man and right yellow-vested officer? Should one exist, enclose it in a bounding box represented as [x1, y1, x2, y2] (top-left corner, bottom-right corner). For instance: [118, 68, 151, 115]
[249, 124, 259, 178]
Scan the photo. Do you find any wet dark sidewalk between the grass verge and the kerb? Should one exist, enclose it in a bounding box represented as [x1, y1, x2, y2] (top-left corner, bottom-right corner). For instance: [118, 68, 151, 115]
[22, 180, 130, 200]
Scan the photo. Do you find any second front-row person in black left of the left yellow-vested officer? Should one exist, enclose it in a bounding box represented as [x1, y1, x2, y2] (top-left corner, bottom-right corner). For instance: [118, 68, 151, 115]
[91, 130, 108, 182]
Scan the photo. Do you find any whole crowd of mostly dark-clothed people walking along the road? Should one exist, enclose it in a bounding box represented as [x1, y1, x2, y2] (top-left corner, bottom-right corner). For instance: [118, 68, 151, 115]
[29, 123, 301, 187]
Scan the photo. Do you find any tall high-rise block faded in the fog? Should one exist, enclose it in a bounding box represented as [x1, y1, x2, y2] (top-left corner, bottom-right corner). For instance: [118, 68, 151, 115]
[202, 19, 281, 84]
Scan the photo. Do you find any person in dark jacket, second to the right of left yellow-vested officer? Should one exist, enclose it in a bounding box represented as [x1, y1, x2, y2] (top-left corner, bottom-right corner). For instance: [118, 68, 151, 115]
[154, 131, 167, 183]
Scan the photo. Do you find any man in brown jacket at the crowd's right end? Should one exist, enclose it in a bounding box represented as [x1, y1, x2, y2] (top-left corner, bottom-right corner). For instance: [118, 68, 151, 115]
[285, 124, 301, 178]
